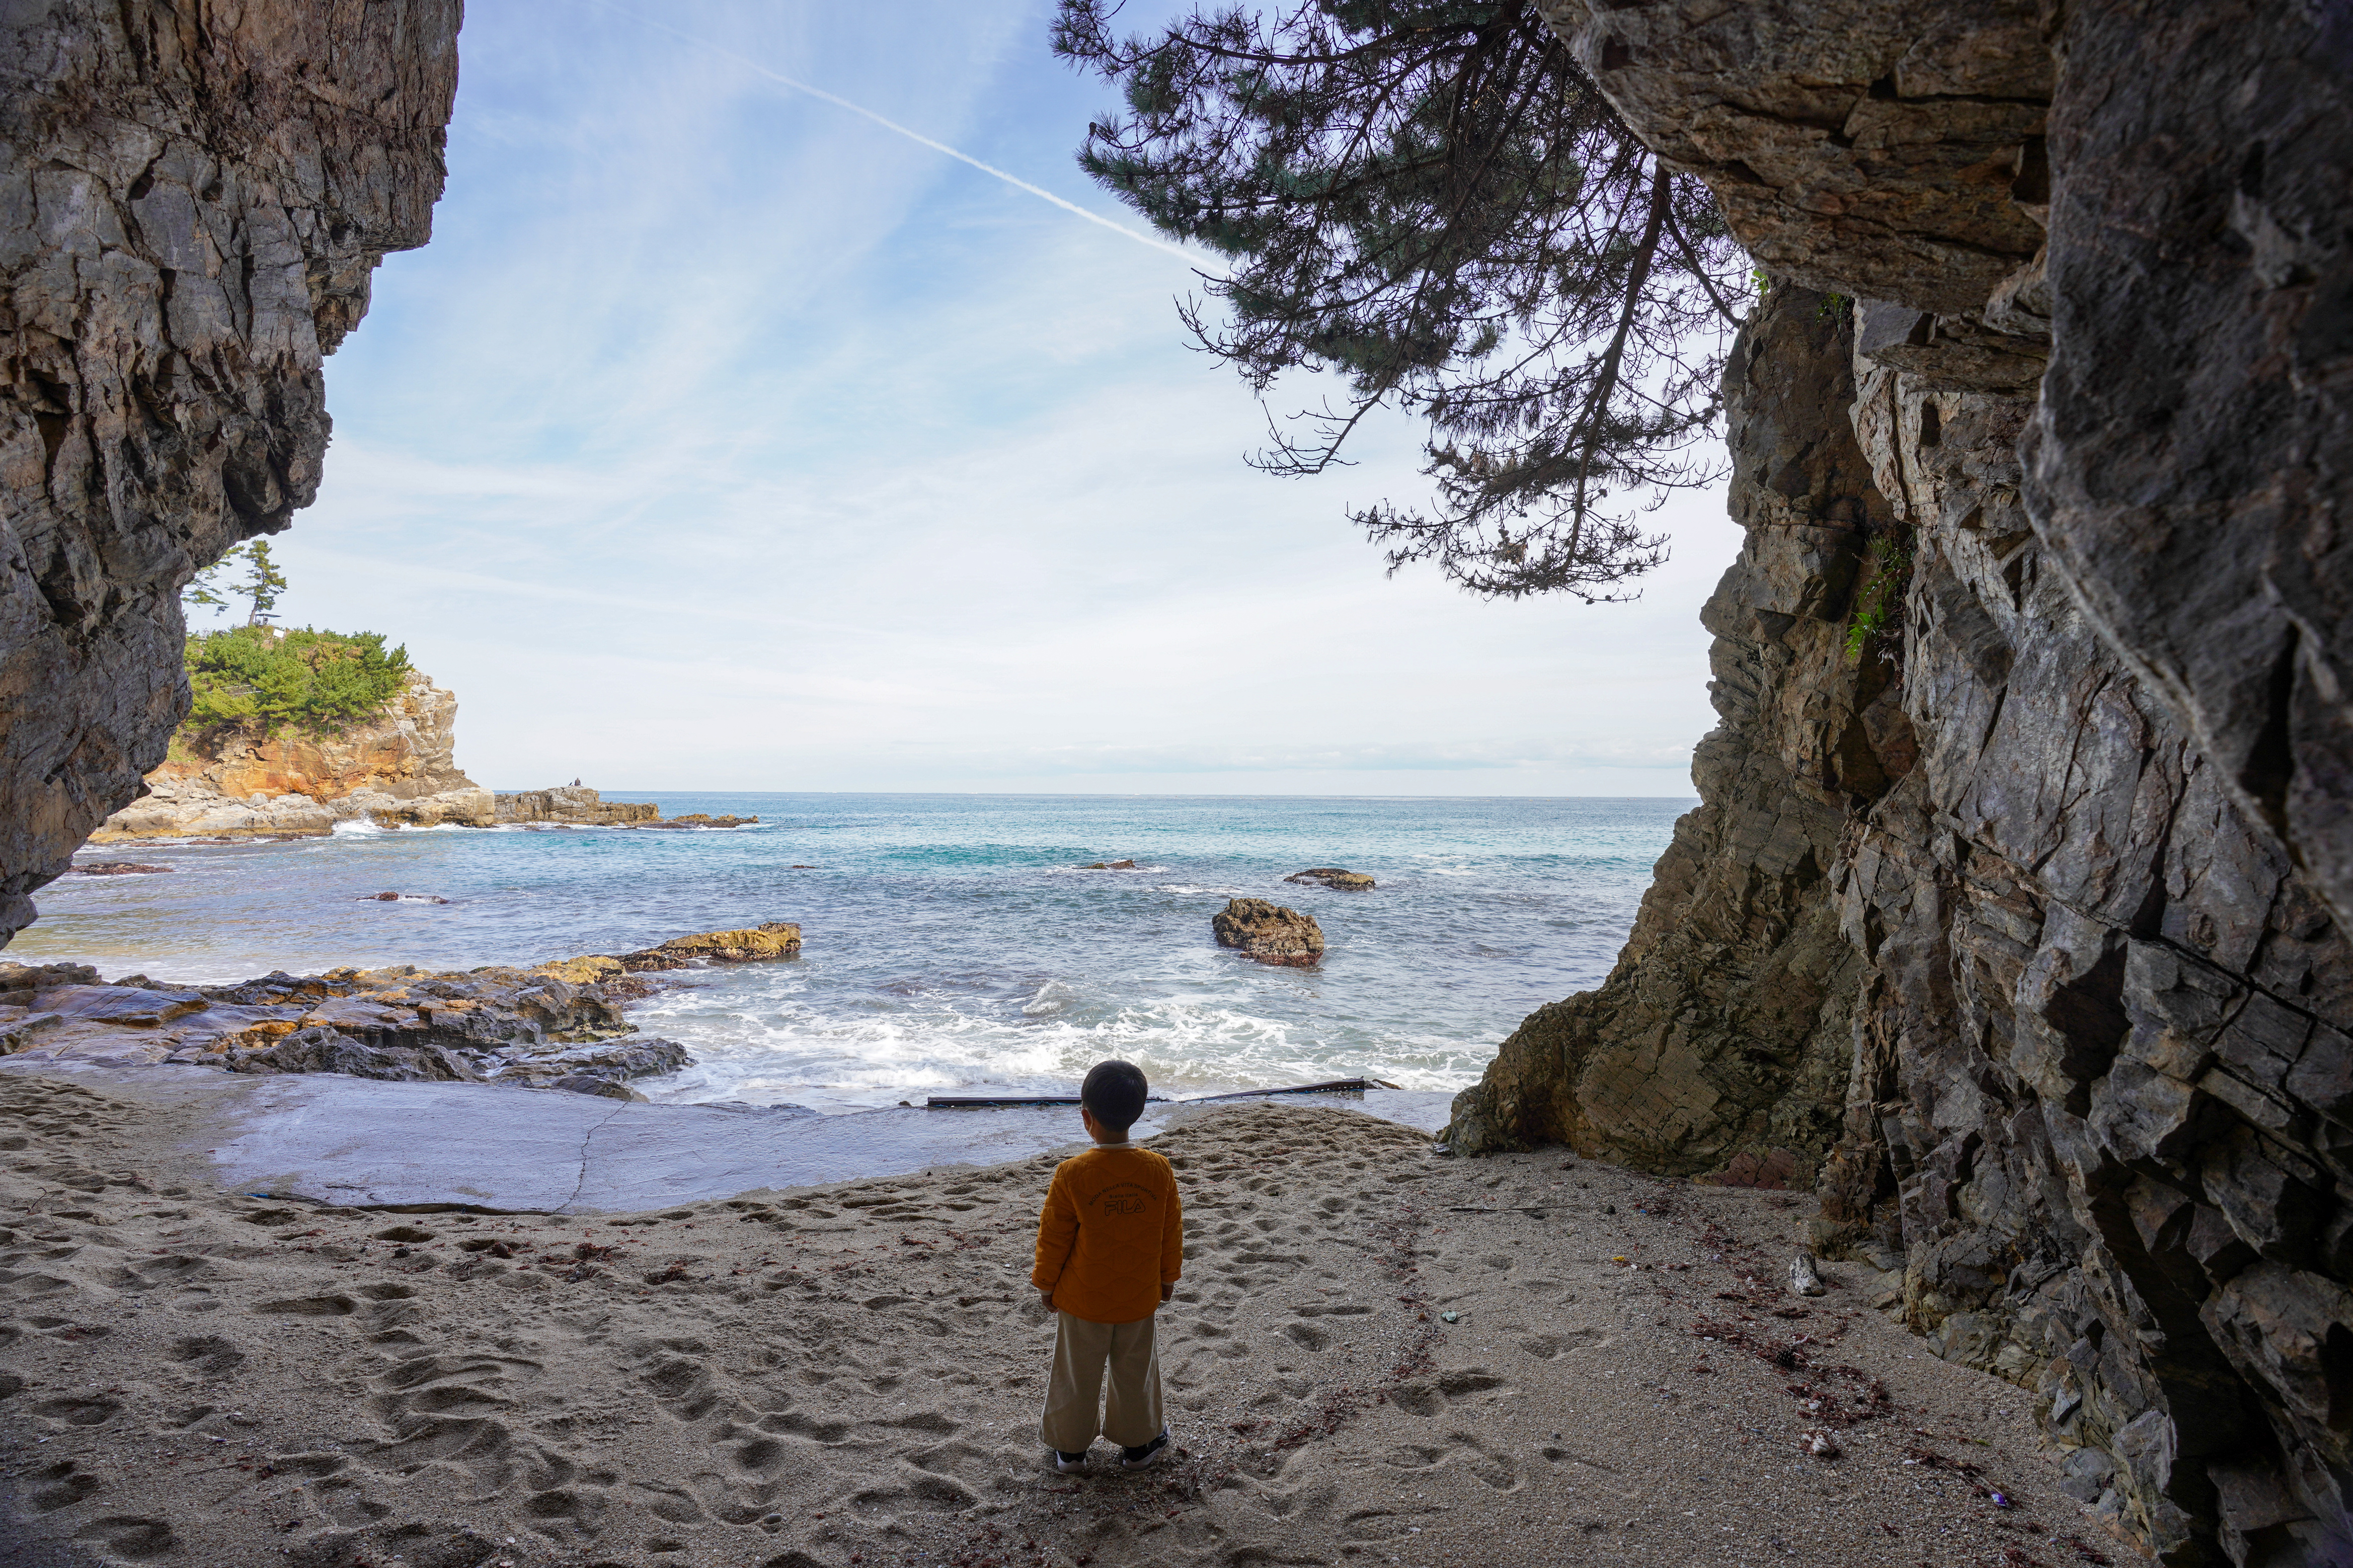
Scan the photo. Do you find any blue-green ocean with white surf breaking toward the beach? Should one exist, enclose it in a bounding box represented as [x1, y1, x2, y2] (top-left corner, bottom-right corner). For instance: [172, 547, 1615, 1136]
[7, 790, 1689, 1112]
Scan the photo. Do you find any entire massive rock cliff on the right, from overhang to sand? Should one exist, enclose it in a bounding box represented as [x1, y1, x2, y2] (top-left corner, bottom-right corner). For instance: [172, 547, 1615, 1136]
[1447, 0, 2353, 1568]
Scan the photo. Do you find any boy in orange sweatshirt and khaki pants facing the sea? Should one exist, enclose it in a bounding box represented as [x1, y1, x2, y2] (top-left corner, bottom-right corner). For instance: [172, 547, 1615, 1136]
[1031, 1062, 1184, 1471]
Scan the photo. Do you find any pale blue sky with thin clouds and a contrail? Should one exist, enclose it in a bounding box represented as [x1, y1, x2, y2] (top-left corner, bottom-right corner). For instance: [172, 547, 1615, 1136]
[211, 0, 1739, 797]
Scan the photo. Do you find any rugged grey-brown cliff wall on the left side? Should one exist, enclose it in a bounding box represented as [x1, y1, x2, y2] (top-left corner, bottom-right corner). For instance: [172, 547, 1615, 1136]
[0, 0, 459, 938]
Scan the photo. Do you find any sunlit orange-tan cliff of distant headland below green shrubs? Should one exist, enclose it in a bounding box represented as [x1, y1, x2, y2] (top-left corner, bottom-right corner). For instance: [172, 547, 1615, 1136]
[90, 670, 497, 844]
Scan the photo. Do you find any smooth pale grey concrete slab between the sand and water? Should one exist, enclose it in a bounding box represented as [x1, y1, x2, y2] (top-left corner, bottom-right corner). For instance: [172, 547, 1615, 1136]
[0, 1062, 1447, 1213]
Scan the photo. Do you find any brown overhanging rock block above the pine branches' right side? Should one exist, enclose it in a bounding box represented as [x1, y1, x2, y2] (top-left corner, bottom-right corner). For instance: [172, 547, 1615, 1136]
[1536, 0, 2057, 315]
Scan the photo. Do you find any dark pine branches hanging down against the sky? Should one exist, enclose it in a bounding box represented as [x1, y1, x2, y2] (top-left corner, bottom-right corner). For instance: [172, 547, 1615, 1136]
[1054, 0, 1751, 602]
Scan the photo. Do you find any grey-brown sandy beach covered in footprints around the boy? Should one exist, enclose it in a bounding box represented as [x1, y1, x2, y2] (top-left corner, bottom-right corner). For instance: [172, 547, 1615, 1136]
[0, 1072, 2144, 1568]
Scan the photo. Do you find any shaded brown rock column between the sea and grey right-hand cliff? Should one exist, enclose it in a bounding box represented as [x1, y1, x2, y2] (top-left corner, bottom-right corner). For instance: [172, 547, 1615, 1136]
[1447, 284, 1915, 1173]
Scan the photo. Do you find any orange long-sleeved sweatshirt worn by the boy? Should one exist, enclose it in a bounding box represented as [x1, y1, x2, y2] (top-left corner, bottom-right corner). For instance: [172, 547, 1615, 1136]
[1031, 1147, 1184, 1324]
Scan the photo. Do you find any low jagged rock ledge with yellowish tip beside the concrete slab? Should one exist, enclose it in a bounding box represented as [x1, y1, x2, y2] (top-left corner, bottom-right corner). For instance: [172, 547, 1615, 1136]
[0, 922, 800, 1100]
